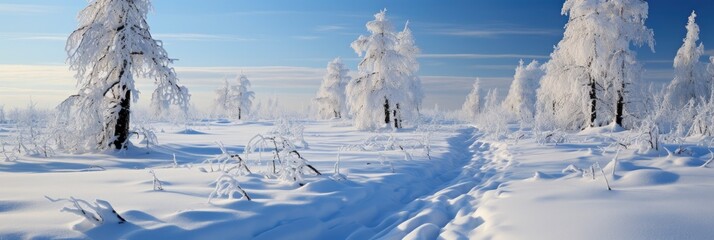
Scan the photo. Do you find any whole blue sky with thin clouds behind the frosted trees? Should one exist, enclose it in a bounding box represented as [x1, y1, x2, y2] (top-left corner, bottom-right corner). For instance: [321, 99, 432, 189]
[0, 0, 714, 109]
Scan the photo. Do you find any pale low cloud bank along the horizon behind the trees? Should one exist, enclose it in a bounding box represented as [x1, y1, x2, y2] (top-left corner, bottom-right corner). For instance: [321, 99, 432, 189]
[0, 65, 510, 109]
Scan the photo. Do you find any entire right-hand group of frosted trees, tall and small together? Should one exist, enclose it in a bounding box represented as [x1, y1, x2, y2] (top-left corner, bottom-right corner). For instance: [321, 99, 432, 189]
[462, 0, 714, 139]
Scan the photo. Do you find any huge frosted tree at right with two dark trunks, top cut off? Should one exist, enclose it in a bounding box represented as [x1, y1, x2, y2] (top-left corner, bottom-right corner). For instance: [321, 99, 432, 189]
[537, 0, 654, 129]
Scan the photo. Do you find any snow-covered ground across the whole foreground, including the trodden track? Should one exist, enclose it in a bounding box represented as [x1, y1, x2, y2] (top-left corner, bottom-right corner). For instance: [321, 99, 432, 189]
[0, 121, 714, 240]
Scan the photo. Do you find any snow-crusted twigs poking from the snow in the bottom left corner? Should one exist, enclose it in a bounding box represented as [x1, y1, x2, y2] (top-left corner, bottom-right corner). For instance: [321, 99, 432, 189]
[45, 196, 126, 226]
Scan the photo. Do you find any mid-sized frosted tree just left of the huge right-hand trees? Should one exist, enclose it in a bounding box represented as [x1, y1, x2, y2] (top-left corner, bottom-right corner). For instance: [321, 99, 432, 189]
[503, 60, 544, 118]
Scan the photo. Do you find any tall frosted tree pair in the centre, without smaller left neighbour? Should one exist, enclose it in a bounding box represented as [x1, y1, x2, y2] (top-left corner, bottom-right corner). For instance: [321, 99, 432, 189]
[347, 9, 421, 130]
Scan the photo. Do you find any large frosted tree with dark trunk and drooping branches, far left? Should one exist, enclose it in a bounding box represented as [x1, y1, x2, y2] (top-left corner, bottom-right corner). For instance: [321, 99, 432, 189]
[61, 0, 189, 151]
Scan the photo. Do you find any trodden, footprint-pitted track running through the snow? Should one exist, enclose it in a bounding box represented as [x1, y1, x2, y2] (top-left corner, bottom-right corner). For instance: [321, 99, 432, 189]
[348, 127, 514, 239]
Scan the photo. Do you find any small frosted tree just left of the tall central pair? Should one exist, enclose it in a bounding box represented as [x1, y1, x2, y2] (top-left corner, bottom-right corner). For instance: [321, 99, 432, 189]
[315, 58, 351, 119]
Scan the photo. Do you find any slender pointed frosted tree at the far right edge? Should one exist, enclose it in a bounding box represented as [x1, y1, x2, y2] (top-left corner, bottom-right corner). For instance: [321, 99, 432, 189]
[665, 12, 711, 110]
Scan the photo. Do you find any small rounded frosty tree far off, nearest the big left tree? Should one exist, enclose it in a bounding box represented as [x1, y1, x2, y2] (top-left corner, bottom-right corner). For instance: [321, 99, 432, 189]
[215, 74, 255, 120]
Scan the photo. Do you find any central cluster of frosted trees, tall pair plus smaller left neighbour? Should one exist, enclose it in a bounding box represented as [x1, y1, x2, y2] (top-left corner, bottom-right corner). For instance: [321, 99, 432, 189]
[315, 9, 424, 130]
